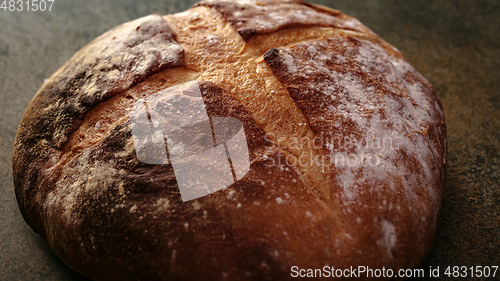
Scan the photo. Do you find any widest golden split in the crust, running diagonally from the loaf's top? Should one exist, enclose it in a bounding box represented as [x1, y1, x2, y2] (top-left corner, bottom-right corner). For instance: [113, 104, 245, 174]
[165, 7, 348, 207]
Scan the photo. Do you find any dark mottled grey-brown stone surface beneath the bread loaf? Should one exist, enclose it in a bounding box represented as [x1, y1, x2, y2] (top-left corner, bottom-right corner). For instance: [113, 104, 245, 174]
[0, 0, 500, 280]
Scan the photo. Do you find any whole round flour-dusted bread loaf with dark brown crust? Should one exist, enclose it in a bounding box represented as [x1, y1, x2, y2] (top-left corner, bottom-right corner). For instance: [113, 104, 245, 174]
[13, 0, 446, 280]
